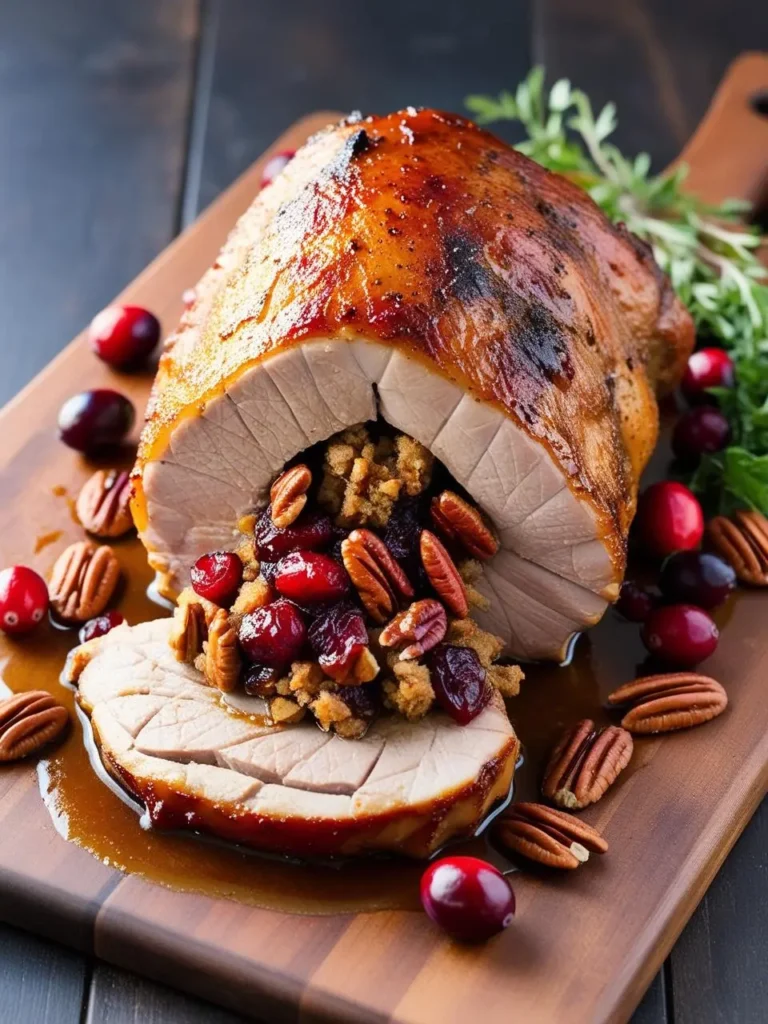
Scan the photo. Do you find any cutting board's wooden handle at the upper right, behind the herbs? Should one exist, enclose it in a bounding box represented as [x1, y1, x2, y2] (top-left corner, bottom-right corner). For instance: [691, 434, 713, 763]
[680, 53, 768, 206]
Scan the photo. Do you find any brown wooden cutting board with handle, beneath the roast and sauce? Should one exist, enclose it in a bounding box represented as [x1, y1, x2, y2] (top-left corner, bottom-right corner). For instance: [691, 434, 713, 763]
[0, 54, 768, 1024]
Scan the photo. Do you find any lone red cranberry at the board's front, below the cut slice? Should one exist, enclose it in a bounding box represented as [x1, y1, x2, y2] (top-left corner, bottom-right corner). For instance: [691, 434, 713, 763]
[421, 857, 515, 942]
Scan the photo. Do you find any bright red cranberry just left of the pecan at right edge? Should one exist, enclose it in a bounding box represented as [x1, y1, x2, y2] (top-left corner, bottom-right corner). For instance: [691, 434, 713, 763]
[637, 480, 703, 558]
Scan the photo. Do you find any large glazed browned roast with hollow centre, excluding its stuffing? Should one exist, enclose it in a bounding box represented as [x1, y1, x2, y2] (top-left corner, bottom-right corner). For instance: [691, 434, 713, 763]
[134, 110, 693, 658]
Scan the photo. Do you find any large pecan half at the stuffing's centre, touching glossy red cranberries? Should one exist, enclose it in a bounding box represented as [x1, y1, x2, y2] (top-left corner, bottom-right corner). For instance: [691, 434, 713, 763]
[341, 529, 414, 623]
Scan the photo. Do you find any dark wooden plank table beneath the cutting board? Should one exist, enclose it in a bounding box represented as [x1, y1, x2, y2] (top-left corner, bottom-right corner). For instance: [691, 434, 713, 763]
[0, 0, 768, 1024]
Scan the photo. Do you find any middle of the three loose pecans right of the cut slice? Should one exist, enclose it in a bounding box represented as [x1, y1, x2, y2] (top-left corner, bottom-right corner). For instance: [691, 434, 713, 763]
[542, 718, 633, 810]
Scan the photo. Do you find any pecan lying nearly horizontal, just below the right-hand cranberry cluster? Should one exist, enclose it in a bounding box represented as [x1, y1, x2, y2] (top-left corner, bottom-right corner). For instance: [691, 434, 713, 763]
[608, 672, 728, 733]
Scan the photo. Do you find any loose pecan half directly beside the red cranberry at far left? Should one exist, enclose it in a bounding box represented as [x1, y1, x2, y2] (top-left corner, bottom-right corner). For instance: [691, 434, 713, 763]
[48, 541, 120, 623]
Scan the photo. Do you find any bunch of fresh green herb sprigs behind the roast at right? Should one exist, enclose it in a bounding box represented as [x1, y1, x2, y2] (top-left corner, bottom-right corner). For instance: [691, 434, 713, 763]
[467, 68, 768, 514]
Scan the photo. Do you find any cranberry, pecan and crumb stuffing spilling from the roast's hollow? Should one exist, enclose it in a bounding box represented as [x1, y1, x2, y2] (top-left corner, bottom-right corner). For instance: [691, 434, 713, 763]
[170, 423, 523, 739]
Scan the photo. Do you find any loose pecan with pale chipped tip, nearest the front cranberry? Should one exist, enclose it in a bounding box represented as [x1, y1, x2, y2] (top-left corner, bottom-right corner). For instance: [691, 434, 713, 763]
[494, 804, 608, 870]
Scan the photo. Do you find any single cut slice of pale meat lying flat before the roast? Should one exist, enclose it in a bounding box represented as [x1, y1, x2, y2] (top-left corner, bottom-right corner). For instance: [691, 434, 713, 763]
[69, 620, 518, 857]
